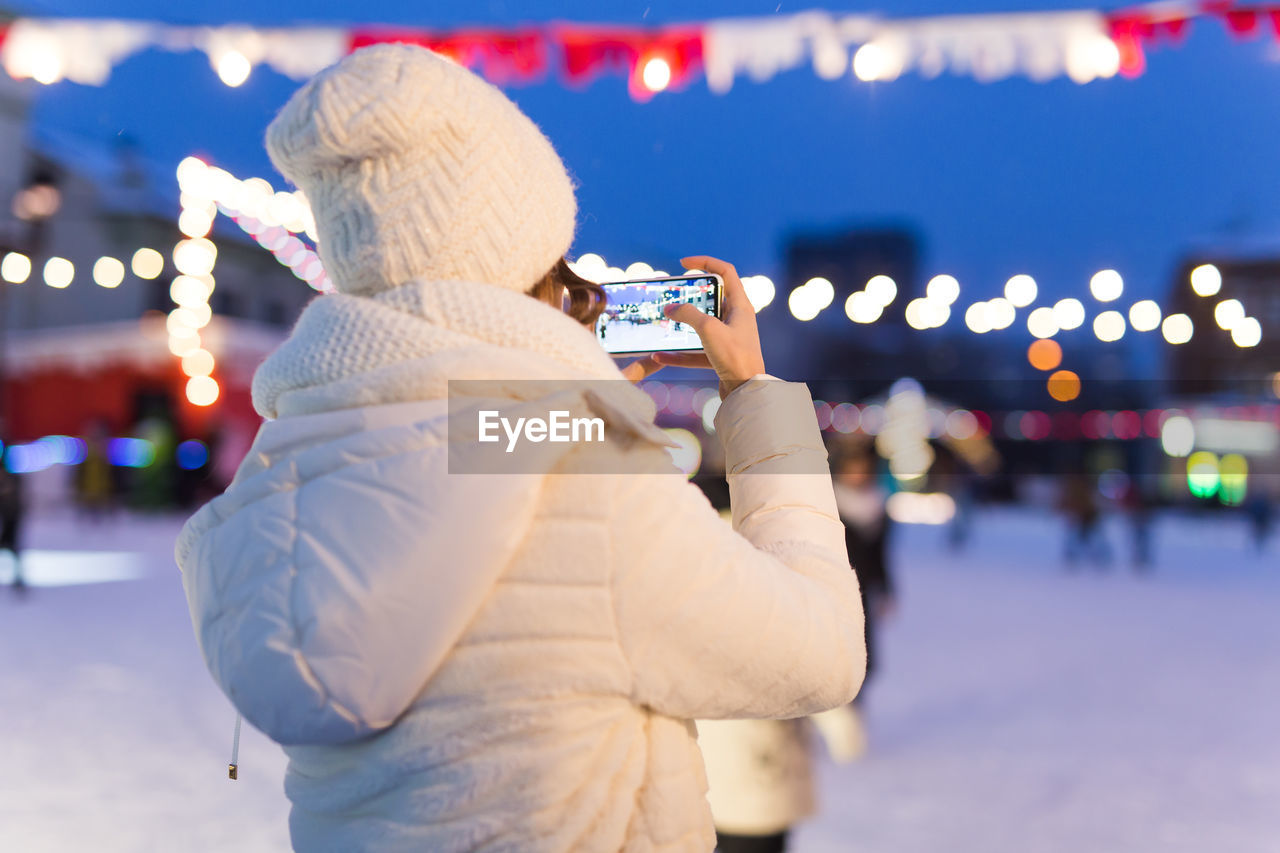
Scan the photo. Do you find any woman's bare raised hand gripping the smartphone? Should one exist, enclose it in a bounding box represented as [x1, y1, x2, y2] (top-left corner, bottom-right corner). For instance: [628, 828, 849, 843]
[655, 255, 764, 400]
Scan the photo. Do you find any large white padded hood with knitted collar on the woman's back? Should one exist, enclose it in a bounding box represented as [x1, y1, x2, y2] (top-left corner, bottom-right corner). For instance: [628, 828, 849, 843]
[177, 283, 667, 744]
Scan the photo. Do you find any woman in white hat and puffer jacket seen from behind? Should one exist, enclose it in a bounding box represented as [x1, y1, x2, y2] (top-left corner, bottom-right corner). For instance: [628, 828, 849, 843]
[178, 46, 864, 850]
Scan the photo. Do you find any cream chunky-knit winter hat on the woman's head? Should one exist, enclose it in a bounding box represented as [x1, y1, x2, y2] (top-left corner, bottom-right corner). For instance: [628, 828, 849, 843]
[266, 45, 576, 295]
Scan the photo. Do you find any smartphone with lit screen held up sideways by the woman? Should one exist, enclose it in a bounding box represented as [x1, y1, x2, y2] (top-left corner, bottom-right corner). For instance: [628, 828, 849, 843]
[595, 273, 724, 355]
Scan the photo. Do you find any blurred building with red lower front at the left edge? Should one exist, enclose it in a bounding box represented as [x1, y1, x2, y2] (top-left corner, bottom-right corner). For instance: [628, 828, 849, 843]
[0, 74, 314, 504]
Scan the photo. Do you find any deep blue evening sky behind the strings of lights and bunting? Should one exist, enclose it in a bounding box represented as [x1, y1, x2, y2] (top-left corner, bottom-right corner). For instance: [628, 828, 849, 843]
[17, 0, 1280, 327]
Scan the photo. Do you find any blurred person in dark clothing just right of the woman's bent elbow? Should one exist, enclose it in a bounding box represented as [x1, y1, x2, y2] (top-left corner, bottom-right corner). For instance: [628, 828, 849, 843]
[835, 446, 897, 752]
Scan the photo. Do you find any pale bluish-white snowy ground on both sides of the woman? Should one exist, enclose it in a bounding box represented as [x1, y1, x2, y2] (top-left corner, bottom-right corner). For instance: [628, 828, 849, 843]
[0, 502, 1280, 853]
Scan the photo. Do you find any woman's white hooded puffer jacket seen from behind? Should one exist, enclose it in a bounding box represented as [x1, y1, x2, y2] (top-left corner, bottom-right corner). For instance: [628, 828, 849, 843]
[178, 275, 864, 853]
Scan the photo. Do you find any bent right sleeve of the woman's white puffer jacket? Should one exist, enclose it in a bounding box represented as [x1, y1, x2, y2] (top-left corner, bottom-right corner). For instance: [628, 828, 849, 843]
[612, 378, 867, 719]
